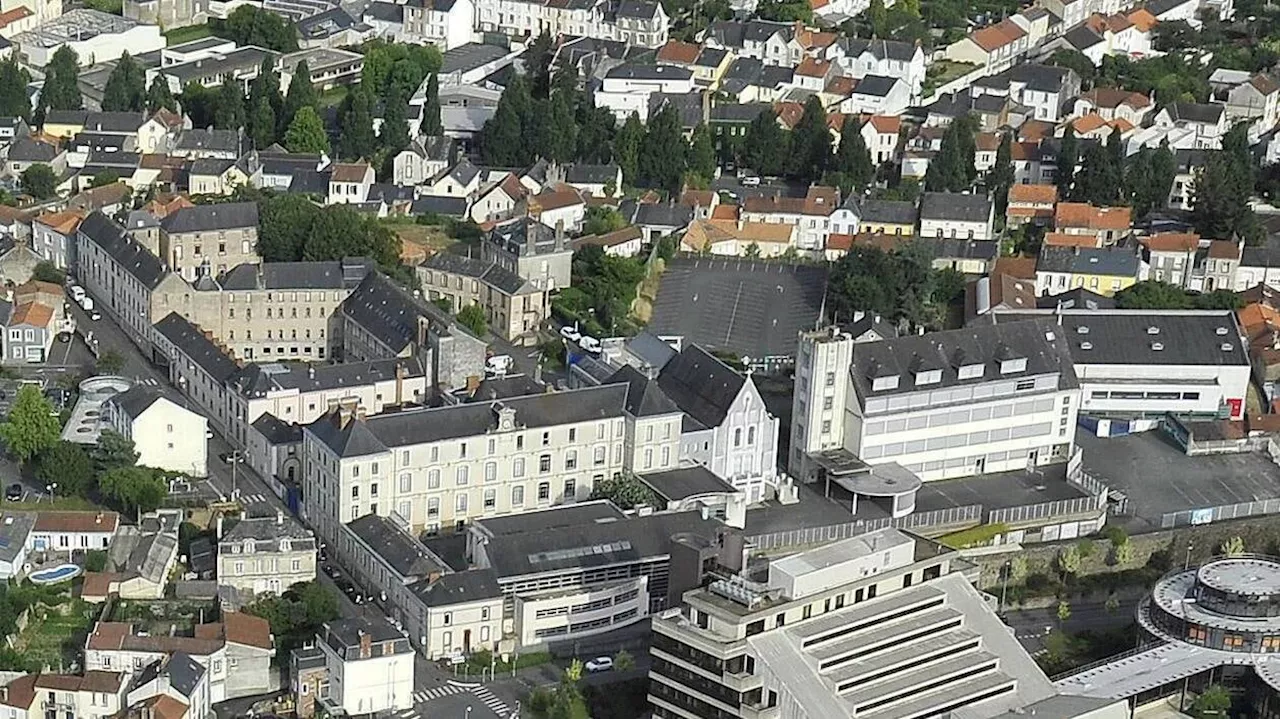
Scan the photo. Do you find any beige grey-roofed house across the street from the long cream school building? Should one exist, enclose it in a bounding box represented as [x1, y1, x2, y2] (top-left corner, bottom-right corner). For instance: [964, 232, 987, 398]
[218, 509, 316, 603]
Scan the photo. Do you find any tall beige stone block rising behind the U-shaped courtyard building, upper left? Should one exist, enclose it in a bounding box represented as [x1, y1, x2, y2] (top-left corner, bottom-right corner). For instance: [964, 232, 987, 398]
[148, 202, 262, 283]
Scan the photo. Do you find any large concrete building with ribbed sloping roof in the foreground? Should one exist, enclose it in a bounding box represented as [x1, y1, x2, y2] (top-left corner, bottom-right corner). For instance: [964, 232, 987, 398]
[649, 528, 1128, 719]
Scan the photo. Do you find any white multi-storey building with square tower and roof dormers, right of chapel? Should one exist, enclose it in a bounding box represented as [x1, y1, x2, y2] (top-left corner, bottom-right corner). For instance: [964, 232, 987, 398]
[787, 320, 1079, 481]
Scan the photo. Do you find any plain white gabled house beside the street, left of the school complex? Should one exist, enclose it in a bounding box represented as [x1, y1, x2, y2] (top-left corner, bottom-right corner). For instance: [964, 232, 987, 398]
[106, 385, 209, 477]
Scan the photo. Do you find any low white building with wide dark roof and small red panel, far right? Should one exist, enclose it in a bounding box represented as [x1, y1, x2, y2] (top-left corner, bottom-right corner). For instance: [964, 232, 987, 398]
[987, 310, 1251, 420]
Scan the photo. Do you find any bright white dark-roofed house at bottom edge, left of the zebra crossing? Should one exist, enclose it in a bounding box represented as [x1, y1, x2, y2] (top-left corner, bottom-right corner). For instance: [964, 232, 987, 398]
[317, 615, 415, 714]
